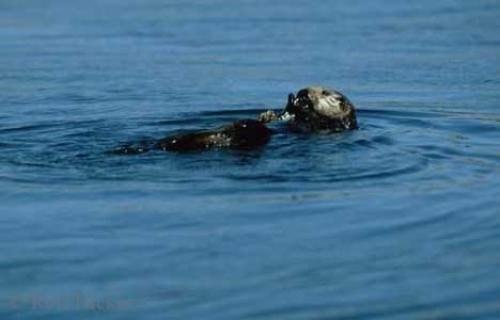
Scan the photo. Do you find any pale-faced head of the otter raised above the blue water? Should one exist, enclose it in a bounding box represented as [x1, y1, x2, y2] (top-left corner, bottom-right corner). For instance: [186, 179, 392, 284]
[281, 87, 358, 132]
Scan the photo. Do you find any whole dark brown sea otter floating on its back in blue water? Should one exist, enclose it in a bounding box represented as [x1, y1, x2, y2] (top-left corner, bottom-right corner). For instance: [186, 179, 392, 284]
[115, 87, 358, 154]
